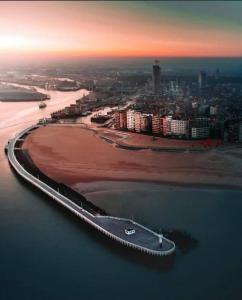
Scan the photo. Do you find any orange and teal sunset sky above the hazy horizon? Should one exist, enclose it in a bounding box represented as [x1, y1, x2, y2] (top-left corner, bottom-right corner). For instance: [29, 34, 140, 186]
[0, 1, 242, 59]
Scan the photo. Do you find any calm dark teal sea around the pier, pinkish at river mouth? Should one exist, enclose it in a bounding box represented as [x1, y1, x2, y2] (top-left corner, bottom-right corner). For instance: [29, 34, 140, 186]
[0, 85, 242, 300]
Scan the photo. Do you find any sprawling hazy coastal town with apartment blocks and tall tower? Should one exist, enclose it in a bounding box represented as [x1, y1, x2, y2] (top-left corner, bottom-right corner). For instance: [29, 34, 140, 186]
[0, 61, 242, 145]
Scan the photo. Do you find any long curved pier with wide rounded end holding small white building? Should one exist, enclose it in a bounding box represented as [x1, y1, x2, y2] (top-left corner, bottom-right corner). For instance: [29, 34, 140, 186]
[8, 125, 175, 256]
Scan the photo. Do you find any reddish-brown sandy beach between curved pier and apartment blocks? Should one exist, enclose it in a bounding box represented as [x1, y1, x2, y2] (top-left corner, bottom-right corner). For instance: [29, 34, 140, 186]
[23, 125, 242, 188]
